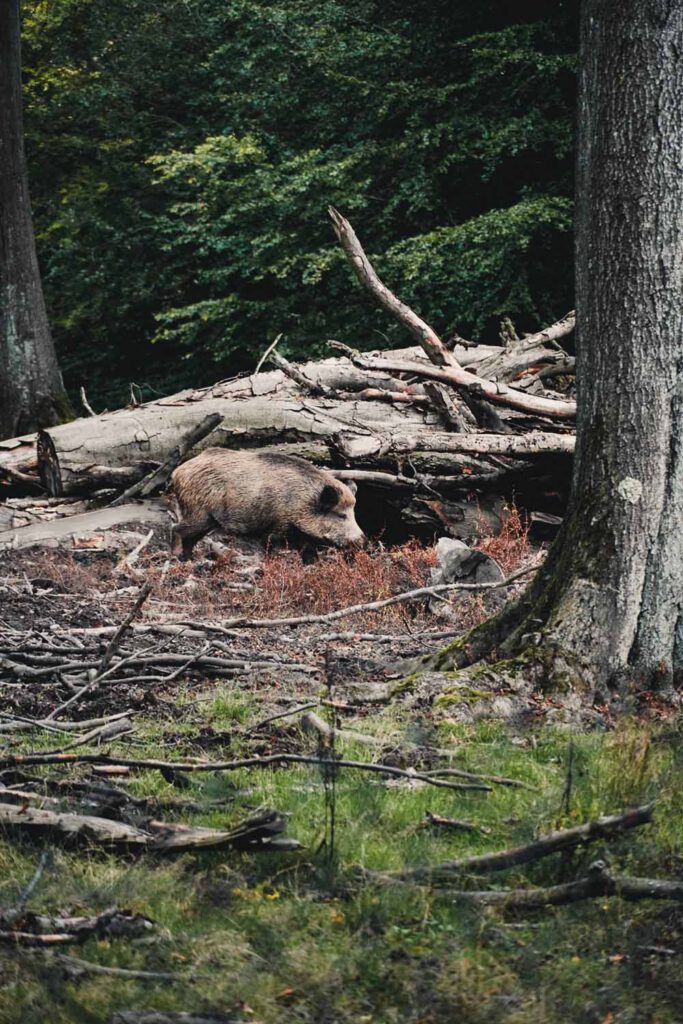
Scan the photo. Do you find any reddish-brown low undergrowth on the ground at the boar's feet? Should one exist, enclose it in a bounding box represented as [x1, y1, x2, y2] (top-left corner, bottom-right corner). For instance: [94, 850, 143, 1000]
[7, 505, 531, 630]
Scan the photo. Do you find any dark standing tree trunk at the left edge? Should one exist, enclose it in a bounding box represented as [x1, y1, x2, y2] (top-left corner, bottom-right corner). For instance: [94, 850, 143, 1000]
[0, 0, 69, 437]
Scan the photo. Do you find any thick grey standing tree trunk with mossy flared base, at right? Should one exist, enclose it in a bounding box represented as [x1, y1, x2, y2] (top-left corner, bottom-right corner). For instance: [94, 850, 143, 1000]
[432, 0, 683, 687]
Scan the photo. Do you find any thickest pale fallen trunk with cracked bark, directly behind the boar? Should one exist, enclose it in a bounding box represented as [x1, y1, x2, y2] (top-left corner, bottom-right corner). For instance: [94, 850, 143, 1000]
[0, 346, 561, 497]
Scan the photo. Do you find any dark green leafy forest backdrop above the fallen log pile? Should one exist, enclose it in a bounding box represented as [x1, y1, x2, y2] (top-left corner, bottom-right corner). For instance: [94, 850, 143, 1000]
[24, 0, 578, 410]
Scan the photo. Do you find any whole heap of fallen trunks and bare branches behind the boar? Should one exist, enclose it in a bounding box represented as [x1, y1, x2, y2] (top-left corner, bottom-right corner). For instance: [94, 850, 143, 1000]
[0, 211, 574, 536]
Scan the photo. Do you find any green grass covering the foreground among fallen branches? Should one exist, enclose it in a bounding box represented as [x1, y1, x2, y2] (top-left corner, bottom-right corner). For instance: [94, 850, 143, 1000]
[0, 708, 683, 1024]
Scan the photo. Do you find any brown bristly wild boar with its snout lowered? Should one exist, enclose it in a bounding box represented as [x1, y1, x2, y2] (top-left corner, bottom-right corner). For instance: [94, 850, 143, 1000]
[171, 449, 367, 559]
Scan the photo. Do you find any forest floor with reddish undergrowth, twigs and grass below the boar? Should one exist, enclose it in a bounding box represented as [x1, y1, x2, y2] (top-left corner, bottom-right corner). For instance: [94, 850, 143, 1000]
[0, 517, 683, 1024]
